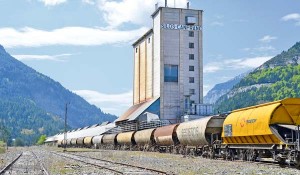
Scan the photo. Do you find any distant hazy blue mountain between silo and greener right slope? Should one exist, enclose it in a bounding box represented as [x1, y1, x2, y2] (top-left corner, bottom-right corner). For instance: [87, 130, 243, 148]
[204, 72, 249, 104]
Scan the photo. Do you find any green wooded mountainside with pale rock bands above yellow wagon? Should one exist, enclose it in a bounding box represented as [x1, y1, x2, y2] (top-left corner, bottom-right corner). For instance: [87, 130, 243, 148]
[215, 42, 300, 112]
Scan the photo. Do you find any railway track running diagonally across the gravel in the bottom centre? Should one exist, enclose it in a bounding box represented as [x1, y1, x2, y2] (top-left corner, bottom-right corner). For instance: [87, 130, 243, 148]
[52, 152, 168, 175]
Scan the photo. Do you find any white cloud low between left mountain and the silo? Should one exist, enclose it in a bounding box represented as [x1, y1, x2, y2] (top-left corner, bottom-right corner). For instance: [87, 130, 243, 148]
[73, 90, 133, 115]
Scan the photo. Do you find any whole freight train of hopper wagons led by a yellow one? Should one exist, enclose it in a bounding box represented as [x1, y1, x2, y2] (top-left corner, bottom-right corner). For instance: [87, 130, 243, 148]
[57, 98, 300, 168]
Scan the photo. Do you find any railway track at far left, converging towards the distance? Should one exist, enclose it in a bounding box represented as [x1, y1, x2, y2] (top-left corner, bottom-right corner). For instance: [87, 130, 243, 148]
[0, 151, 49, 175]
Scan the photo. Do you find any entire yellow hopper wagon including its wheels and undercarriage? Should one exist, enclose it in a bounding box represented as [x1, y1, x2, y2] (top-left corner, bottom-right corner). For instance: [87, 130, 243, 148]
[222, 98, 300, 167]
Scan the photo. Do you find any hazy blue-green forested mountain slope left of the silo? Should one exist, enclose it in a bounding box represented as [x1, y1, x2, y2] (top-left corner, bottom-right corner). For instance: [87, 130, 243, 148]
[0, 45, 116, 145]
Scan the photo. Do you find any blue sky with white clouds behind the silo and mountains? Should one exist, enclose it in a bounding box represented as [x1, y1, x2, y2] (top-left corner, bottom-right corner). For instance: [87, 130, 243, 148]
[0, 0, 300, 115]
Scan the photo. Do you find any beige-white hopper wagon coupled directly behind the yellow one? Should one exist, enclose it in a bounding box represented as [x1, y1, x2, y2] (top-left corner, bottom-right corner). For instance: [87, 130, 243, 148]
[176, 116, 225, 156]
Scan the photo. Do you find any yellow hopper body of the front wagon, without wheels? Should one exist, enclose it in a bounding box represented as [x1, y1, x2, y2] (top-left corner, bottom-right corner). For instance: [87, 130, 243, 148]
[222, 98, 300, 144]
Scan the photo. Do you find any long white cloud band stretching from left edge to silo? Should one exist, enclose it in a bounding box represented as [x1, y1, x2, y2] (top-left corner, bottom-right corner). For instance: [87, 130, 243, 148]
[0, 27, 148, 48]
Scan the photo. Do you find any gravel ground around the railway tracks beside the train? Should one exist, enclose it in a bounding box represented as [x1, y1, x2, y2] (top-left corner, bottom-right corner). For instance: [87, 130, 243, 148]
[0, 147, 300, 175]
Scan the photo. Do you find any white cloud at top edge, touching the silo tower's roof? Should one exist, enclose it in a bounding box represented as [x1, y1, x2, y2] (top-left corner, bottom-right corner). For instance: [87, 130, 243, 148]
[98, 0, 187, 28]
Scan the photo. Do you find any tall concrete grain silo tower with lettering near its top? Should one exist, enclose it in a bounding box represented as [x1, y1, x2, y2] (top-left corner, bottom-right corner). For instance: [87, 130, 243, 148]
[118, 4, 211, 126]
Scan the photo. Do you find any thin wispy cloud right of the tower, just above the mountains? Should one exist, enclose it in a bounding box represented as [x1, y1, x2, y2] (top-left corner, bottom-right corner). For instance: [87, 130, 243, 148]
[203, 56, 273, 73]
